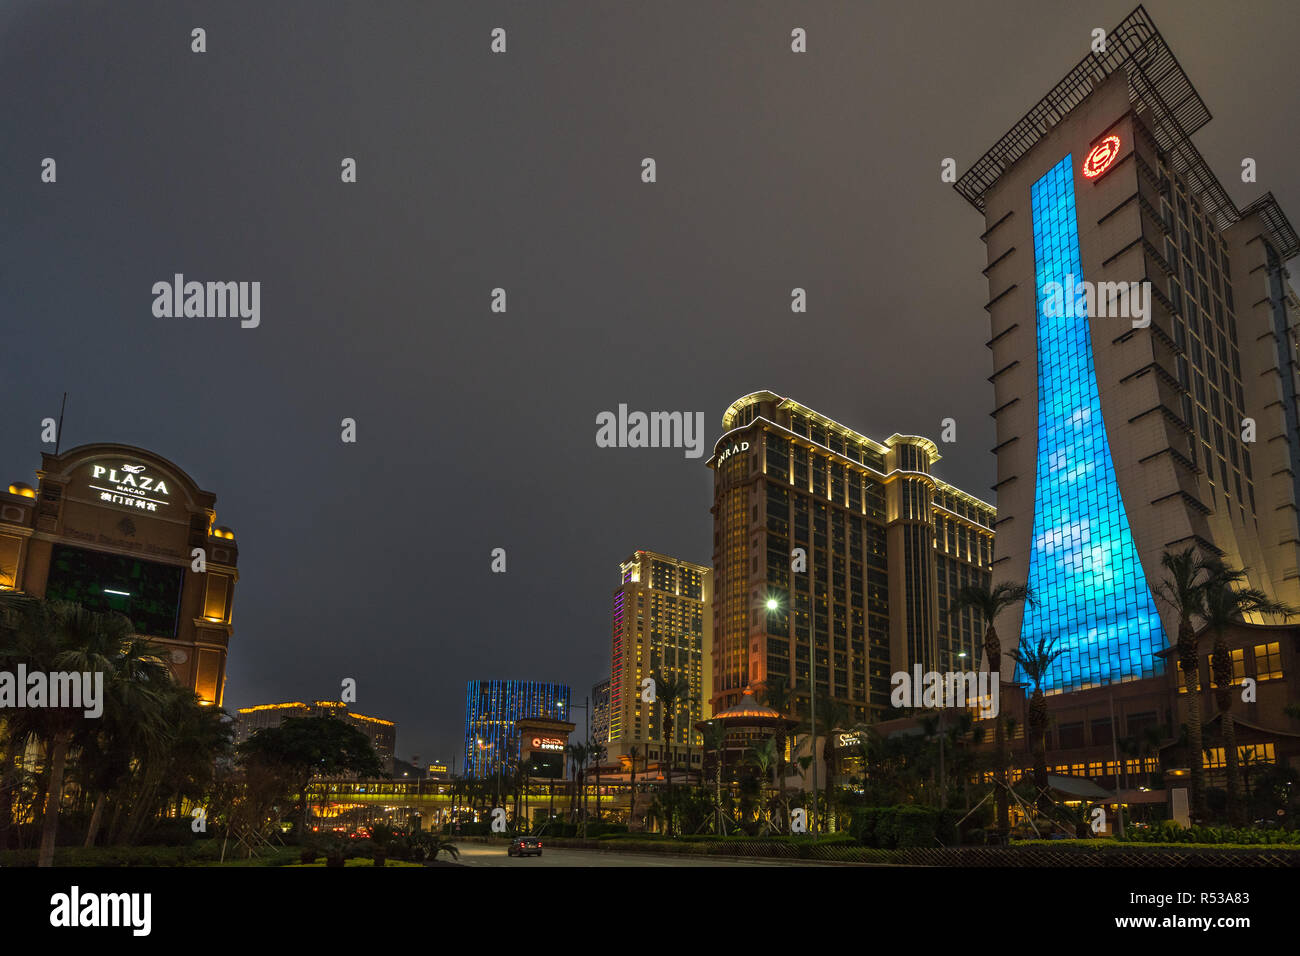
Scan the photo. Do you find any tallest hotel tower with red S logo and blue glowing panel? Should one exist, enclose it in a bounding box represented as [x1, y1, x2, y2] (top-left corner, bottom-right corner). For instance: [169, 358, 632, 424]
[956, 7, 1300, 773]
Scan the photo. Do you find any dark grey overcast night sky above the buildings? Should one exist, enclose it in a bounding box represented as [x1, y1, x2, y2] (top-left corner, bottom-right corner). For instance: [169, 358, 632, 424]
[0, 0, 1300, 760]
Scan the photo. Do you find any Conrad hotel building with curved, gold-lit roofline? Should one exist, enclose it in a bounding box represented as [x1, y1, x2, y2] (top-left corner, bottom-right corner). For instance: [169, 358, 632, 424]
[707, 392, 995, 723]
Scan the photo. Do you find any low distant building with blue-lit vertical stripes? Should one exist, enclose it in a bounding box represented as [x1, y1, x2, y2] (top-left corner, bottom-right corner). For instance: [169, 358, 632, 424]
[465, 680, 569, 777]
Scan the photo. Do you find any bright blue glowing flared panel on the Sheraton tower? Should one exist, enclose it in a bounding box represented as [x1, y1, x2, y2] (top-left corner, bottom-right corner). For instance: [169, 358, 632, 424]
[1017, 156, 1165, 691]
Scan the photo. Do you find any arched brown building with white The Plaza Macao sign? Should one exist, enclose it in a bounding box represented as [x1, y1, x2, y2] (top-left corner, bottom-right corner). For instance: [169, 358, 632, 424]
[0, 444, 239, 705]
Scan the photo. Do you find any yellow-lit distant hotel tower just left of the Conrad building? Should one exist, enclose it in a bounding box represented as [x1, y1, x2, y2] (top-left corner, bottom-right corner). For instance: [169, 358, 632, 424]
[606, 551, 714, 769]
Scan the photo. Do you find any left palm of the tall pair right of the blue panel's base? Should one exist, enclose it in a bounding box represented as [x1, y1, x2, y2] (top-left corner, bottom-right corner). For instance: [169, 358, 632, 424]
[1153, 546, 1223, 823]
